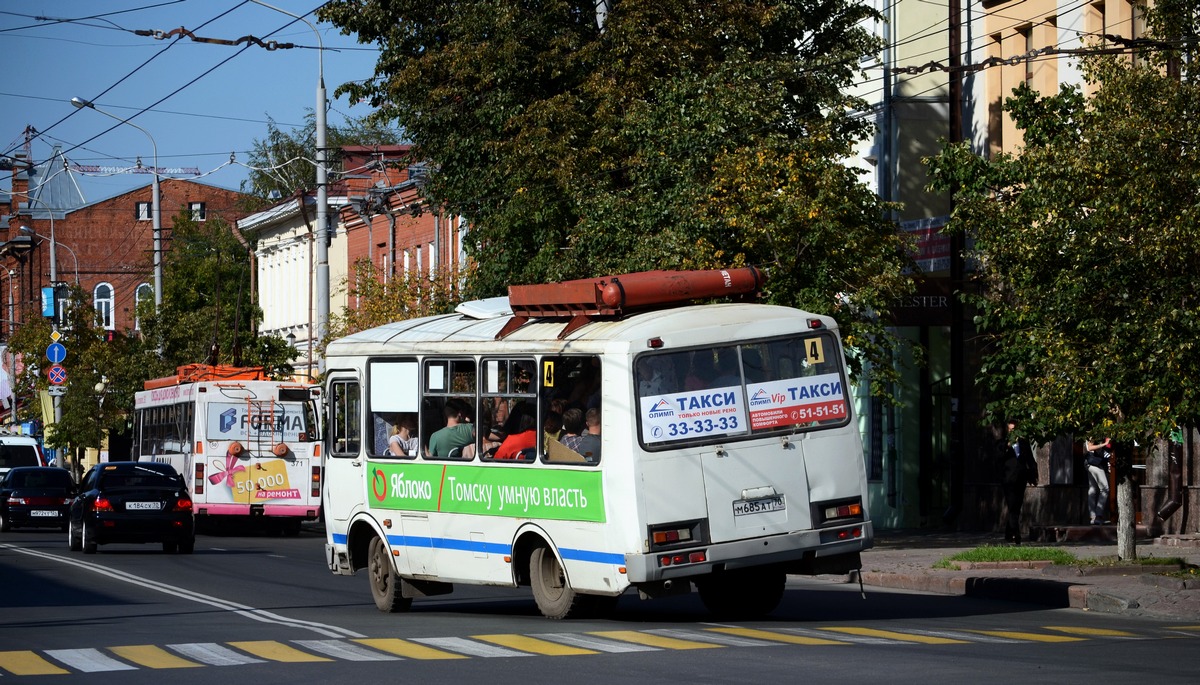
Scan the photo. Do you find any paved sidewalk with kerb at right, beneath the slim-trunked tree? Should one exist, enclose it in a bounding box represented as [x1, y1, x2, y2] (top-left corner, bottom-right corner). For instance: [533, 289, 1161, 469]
[848, 530, 1200, 621]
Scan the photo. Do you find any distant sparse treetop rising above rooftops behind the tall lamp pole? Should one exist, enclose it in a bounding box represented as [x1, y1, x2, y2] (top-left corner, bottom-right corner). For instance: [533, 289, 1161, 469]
[241, 109, 402, 202]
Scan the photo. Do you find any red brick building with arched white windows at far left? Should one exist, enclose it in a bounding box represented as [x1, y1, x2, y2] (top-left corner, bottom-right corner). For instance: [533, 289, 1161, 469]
[0, 150, 245, 340]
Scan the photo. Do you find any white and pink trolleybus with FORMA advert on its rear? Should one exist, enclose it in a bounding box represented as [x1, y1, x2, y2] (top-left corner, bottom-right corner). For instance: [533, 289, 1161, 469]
[133, 365, 323, 535]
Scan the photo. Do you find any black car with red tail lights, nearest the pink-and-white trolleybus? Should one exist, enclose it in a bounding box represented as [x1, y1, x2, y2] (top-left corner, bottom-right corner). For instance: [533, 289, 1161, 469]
[67, 462, 196, 554]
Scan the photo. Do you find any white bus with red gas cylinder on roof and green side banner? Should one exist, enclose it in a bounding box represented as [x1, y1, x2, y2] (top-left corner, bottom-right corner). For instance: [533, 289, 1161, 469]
[324, 269, 872, 618]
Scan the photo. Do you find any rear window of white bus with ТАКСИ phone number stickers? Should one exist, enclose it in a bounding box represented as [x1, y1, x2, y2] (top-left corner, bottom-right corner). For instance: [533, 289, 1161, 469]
[635, 331, 850, 449]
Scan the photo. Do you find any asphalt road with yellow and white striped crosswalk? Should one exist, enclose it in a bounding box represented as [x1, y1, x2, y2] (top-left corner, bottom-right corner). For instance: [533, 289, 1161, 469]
[0, 523, 1200, 685]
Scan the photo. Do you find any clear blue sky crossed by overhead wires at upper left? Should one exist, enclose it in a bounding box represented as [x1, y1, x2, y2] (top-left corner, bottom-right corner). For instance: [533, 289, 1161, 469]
[0, 0, 378, 202]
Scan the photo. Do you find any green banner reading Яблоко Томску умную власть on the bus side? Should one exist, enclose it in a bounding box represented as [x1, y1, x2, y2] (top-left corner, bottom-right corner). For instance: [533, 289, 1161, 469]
[367, 462, 605, 523]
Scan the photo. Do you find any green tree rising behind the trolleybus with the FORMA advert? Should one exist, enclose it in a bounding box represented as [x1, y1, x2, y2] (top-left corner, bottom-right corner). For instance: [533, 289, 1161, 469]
[138, 212, 295, 378]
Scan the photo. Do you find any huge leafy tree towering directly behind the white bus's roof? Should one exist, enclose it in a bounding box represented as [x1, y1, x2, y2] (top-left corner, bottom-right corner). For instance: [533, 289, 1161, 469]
[319, 0, 911, 386]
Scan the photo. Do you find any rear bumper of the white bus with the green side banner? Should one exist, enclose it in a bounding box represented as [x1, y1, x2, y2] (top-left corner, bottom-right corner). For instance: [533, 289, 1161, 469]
[625, 521, 874, 584]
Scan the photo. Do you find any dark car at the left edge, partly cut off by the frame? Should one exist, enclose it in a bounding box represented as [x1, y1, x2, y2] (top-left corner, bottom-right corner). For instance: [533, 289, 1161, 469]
[0, 467, 76, 530]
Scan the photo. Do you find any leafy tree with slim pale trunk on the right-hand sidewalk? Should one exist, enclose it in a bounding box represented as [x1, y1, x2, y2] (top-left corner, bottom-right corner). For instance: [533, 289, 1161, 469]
[929, 0, 1200, 555]
